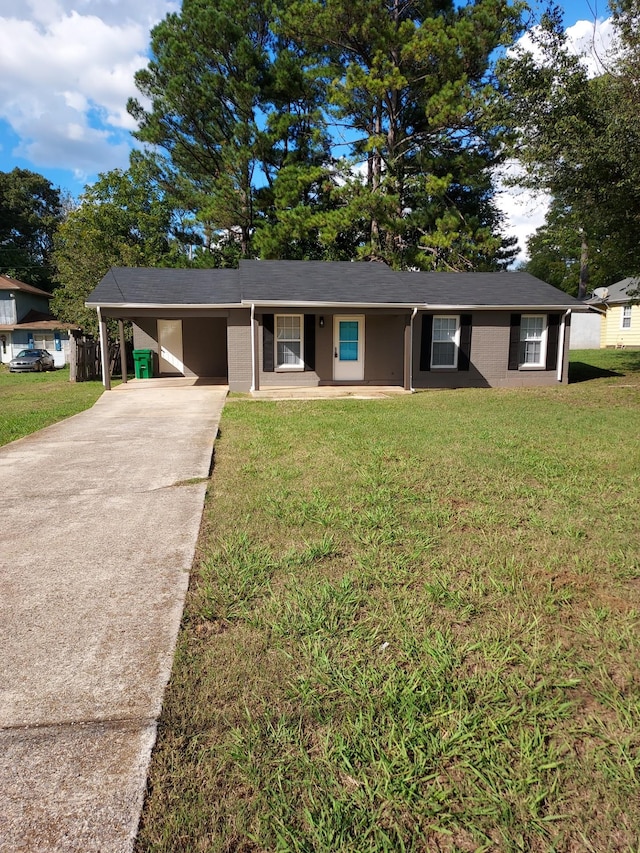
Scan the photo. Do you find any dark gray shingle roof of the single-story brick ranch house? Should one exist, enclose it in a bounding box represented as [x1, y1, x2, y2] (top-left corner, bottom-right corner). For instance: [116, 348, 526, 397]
[87, 261, 584, 309]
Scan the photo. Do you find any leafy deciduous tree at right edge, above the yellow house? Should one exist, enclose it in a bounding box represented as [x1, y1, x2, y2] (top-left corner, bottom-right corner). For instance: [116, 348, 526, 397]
[501, 5, 640, 297]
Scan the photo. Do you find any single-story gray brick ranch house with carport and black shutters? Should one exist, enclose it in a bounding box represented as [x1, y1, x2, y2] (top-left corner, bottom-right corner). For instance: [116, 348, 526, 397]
[87, 261, 589, 391]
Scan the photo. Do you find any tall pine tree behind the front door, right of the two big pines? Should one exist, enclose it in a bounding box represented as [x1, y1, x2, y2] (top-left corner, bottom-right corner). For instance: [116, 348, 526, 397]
[283, 0, 519, 269]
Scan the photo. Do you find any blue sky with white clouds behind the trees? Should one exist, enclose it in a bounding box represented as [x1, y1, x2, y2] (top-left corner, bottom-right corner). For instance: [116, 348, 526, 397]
[0, 0, 608, 258]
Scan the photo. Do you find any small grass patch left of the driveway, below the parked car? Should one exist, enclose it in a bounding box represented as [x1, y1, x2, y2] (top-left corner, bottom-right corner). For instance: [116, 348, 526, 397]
[0, 367, 104, 445]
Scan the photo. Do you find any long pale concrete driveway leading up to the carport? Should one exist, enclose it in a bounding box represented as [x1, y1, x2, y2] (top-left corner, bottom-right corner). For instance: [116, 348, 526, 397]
[0, 380, 227, 853]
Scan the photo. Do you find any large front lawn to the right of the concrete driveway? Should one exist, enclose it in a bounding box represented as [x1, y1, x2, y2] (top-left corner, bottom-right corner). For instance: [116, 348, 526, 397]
[136, 351, 640, 853]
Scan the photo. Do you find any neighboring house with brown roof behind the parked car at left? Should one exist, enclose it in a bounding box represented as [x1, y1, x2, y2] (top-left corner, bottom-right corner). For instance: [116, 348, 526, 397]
[0, 275, 76, 367]
